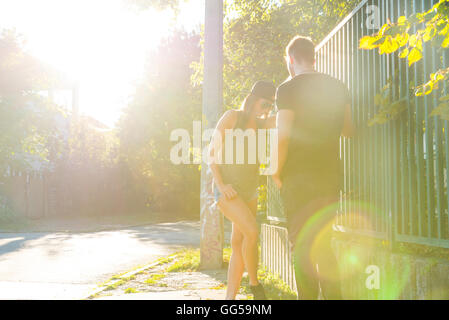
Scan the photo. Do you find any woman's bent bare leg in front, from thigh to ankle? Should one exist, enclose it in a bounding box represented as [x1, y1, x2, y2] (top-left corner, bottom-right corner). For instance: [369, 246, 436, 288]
[218, 196, 259, 286]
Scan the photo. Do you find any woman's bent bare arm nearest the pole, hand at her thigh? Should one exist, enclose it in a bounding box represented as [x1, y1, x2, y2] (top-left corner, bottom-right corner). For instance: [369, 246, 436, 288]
[209, 110, 237, 199]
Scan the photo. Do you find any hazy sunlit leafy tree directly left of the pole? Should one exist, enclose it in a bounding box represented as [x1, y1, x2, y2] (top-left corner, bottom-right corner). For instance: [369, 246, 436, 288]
[119, 31, 201, 215]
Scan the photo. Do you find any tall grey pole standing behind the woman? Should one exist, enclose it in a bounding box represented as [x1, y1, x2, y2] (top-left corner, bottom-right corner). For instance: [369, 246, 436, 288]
[200, 0, 224, 269]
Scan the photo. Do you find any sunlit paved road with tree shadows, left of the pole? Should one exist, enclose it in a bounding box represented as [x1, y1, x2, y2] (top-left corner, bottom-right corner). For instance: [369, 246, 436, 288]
[0, 222, 200, 299]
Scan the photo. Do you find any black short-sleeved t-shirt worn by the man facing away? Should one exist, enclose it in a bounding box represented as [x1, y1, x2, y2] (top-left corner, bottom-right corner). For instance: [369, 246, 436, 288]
[276, 72, 350, 194]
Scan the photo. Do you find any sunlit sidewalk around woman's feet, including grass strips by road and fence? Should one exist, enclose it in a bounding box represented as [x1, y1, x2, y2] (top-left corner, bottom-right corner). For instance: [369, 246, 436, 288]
[88, 248, 296, 300]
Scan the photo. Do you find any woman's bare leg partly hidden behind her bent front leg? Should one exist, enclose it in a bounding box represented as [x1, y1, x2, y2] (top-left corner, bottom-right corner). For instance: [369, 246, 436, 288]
[226, 199, 258, 300]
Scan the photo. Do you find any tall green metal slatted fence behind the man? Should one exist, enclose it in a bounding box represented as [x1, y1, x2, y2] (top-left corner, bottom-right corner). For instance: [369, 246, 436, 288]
[267, 0, 449, 248]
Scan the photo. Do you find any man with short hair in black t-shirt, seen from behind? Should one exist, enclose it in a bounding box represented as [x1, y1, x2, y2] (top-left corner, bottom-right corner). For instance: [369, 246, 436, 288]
[273, 37, 353, 299]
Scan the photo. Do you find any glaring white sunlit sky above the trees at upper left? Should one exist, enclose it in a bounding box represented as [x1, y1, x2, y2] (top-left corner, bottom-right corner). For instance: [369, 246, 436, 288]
[0, 0, 205, 127]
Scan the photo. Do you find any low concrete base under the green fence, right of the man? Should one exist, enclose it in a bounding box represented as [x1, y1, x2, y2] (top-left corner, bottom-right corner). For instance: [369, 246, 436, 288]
[333, 238, 449, 300]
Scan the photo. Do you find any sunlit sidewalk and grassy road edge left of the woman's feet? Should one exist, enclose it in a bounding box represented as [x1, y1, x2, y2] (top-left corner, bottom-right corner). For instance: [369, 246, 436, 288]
[89, 251, 252, 300]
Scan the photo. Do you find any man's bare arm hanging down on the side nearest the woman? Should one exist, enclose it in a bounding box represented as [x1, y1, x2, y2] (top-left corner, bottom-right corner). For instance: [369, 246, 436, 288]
[273, 110, 295, 188]
